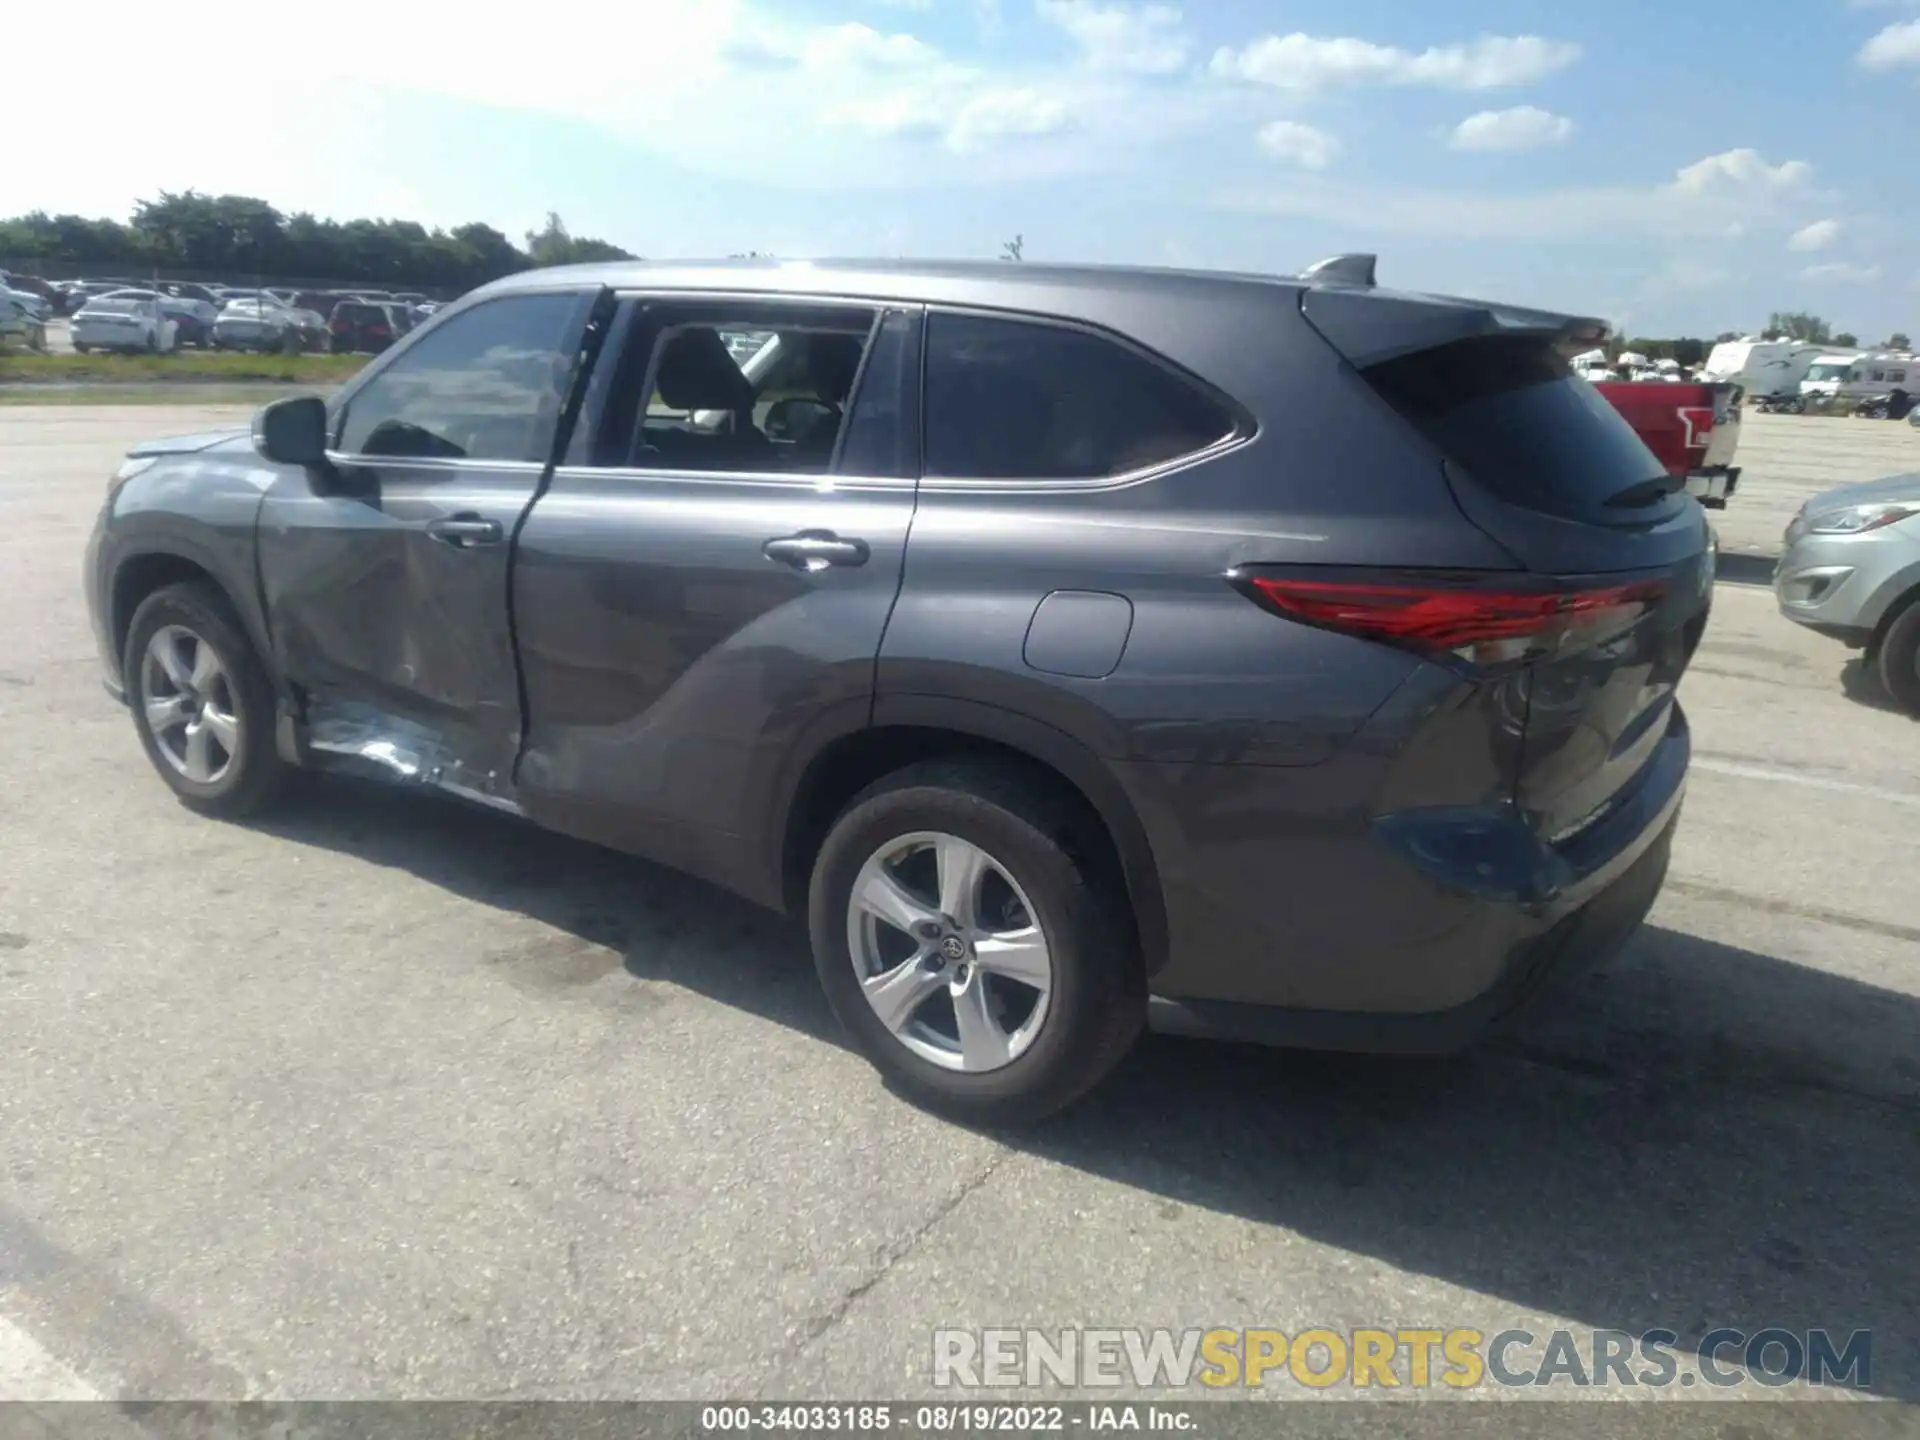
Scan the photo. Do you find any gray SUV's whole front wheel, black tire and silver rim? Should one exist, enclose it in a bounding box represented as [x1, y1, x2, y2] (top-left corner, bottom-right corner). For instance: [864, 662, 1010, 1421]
[125, 584, 288, 816]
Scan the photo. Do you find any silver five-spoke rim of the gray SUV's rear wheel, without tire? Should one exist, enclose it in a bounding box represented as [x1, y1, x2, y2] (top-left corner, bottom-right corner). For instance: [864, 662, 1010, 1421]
[847, 831, 1054, 1073]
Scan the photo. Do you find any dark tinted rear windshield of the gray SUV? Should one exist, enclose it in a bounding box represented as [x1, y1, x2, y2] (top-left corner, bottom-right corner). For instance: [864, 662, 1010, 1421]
[1365, 336, 1674, 524]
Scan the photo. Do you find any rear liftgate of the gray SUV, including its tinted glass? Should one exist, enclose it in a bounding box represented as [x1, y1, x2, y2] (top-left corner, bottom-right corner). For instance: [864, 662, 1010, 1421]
[1363, 334, 1713, 839]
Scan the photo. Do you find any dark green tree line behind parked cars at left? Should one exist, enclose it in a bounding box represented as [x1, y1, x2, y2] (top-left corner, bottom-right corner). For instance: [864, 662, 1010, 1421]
[0, 190, 636, 294]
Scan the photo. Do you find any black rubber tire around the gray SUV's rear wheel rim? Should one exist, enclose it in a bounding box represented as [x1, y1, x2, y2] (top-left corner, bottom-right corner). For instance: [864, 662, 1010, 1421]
[808, 760, 1146, 1125]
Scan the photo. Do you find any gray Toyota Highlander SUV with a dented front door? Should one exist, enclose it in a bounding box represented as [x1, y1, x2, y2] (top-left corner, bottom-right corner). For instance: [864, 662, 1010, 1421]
[86, 255, 1713, 1121]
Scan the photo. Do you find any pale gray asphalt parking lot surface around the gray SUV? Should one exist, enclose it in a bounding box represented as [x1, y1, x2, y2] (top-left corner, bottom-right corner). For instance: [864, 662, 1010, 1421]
[0, 407, 1920, 1400]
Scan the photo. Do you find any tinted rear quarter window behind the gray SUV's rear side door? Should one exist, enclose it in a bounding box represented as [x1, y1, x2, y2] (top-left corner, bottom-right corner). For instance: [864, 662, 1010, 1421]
[925, 313, 1235, 480]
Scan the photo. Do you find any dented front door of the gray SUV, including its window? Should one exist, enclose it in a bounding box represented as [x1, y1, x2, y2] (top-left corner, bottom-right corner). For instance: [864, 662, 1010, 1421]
[259, 290, 595, 799]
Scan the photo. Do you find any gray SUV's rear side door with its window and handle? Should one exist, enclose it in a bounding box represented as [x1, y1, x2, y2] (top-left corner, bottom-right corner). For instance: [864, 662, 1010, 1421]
[515, 298, 920, 893]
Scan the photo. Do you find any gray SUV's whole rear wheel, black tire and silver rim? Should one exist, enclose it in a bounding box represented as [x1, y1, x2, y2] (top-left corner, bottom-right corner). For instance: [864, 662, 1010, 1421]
[810, 762, 1144, 1123]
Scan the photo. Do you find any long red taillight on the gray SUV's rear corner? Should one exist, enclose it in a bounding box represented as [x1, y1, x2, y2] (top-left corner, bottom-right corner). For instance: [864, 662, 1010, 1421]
[1240, 574, 1667, 664]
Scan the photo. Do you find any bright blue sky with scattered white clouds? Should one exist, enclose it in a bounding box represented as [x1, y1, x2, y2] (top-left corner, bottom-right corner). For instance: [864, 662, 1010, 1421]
[15, 0, 1920, 340]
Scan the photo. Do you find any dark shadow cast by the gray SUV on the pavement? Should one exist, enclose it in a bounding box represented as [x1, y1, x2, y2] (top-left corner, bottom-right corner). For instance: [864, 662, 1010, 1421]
[261, 781, 1920, 1400]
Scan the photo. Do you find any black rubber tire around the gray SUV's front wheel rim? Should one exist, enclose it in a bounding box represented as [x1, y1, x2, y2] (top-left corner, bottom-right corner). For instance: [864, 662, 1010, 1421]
[121, 580, 292, 820]
